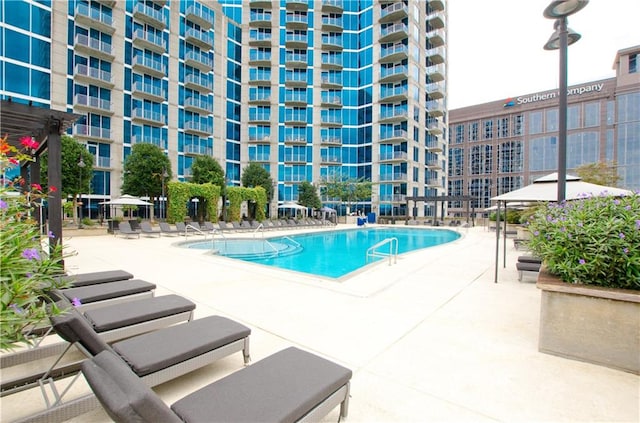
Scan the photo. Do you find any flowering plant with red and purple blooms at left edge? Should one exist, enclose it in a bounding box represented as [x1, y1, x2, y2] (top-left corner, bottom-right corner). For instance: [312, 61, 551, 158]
[0, 136, 68, 350]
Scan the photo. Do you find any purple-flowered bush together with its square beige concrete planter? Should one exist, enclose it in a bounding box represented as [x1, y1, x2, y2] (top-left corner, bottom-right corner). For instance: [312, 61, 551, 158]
[528, 193, 640, 374]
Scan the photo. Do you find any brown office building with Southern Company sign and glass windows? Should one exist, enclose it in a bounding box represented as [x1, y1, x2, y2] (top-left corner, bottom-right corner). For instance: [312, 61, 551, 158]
[447, 46, 640, 215]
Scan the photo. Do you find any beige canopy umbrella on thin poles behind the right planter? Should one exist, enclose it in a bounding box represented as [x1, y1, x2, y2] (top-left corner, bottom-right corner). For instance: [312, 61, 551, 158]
[491, 172, 632, 283]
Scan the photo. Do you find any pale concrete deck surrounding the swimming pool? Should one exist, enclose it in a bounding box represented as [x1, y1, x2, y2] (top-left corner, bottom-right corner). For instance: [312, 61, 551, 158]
[0, 227, 640, 422]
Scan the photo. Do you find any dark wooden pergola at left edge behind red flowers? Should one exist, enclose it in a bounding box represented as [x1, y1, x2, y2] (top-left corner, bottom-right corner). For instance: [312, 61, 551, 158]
[0, 98, 81, 255]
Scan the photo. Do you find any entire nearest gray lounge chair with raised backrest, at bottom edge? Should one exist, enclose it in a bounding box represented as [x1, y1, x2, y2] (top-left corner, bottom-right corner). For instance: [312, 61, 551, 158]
[82, 348, 352, 423]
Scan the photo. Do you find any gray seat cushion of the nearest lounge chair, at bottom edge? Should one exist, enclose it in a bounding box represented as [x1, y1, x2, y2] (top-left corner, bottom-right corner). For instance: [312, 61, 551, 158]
[171, 347, 351, 423]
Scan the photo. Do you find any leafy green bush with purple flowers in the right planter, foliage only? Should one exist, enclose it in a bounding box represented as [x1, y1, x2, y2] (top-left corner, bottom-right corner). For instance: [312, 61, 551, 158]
[528, 193, 640, 290]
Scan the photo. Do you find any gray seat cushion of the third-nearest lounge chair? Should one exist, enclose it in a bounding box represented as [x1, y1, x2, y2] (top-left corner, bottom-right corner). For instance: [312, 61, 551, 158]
[84, 294, 196, 332]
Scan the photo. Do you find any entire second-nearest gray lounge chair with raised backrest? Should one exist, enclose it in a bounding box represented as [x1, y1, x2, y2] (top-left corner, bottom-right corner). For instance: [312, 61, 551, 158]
[25, 309, 251, 422]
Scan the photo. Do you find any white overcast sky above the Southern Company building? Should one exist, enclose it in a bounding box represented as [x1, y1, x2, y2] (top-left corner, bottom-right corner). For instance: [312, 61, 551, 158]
[447, 0, 640, 110]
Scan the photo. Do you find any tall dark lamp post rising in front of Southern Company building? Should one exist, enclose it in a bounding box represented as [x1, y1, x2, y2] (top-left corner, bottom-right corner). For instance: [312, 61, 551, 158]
[543, 0, 589, 203]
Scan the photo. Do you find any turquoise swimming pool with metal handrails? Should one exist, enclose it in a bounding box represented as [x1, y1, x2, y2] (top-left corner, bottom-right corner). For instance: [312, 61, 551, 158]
[187, 227, 460, 279]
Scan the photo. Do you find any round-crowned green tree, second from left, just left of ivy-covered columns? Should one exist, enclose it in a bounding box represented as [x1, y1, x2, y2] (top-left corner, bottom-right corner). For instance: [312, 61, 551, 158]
[122, 143, 171, 219]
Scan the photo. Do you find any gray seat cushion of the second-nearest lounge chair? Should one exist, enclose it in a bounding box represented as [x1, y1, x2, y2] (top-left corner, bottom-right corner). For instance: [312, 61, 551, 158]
[112, 316, 251, 376]
